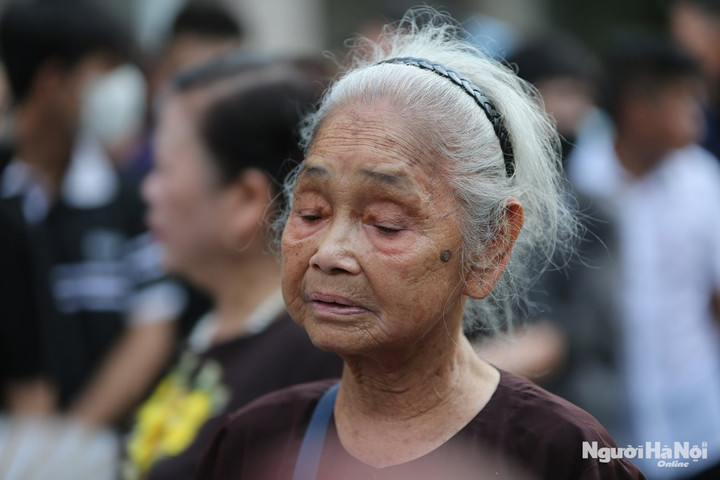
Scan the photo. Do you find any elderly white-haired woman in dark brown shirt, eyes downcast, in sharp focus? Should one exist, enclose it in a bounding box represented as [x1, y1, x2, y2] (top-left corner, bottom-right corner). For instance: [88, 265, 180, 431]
[197, 14, 644, 480]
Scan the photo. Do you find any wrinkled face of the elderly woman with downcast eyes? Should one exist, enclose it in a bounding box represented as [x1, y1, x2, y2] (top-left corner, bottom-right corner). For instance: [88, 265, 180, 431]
[282, 102, 464, 355]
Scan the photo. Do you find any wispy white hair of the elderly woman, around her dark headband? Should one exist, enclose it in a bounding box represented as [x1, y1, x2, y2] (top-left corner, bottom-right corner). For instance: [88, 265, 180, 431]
[272, 7, 576, 333]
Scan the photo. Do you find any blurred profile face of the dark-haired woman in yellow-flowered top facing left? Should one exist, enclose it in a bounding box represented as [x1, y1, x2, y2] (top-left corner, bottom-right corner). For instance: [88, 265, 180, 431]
[143, 95, 235, 277]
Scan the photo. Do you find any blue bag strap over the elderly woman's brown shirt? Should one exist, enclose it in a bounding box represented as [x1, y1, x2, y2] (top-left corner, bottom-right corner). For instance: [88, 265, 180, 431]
[292, 382, 340, 480]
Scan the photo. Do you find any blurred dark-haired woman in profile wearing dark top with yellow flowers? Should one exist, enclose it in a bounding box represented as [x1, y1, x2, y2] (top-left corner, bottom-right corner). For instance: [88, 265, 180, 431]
[123, 53, 342, 480]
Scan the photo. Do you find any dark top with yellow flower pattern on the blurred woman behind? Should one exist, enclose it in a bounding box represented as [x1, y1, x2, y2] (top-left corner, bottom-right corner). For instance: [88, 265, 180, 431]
[126, 313, 342, 480]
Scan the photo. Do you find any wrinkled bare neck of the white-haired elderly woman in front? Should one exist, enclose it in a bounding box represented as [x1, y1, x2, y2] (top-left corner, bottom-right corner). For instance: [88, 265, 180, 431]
[335, 318, 499, 467]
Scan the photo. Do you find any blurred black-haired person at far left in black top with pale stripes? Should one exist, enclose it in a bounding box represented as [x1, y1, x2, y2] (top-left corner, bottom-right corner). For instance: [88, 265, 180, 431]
[0, 1, 180, 432]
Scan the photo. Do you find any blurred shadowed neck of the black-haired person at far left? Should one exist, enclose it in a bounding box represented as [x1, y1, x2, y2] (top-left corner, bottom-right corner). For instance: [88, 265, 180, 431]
[16, 105, 75, 197]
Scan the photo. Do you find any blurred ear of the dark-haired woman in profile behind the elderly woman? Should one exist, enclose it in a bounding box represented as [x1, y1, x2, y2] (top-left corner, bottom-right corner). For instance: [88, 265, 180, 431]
[227, 168, 273, 245]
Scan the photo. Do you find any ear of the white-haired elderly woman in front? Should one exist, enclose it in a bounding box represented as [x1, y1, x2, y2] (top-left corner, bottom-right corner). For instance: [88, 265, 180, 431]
[463, 198, 525, 299]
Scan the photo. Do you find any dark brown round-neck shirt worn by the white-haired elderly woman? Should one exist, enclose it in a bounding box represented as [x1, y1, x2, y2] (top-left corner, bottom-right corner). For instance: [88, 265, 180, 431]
[196, 372, 645, 480]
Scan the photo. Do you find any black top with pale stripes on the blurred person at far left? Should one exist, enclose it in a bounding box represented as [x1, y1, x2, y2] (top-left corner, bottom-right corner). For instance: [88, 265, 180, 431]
[0, 143, 170, 408]
